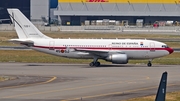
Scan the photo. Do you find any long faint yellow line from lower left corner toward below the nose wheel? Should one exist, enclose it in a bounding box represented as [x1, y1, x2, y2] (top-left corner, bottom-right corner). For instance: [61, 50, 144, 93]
[2, 79, 148, 99]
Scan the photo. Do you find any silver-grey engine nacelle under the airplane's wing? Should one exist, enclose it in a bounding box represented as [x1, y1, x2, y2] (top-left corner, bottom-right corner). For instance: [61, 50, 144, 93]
[106, 54, 128, 64]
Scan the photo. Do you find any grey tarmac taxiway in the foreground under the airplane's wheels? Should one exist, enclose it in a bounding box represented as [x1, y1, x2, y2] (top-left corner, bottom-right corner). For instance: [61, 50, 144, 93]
[0, 63, 180, 101]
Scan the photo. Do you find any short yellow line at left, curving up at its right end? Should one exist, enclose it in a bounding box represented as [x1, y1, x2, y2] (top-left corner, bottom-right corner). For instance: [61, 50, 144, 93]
[0, 77, 57, 90]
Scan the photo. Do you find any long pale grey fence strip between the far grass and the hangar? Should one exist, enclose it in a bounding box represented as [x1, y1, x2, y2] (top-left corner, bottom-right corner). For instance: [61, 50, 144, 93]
[0, 24, 180, 33]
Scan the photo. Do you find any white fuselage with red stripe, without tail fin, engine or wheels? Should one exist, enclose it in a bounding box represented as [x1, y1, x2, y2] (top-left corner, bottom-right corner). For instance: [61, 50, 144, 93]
[28, 39, 171, 59]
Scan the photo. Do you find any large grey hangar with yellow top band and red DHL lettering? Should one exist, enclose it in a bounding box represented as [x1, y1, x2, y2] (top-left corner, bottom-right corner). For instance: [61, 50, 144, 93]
[54, 0, 180, 25]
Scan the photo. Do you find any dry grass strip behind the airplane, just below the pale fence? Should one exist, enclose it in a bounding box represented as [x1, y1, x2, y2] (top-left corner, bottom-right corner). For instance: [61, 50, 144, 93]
[0, 31, 180, 41]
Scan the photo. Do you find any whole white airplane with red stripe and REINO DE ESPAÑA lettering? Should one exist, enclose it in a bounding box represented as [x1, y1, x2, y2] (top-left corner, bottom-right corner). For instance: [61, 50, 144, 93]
[7, 9, 174, 67]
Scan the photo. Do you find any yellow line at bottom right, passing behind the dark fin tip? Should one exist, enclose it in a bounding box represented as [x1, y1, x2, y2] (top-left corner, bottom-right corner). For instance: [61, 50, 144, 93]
[60, 84, 178, 101]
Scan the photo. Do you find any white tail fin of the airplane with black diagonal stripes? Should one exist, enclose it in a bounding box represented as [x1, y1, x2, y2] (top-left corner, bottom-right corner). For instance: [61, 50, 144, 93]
[7, 9, 50, 39]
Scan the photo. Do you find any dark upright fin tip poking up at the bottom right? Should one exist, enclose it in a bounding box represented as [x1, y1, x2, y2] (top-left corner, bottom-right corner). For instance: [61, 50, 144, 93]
[155, 72, 167, 101]
